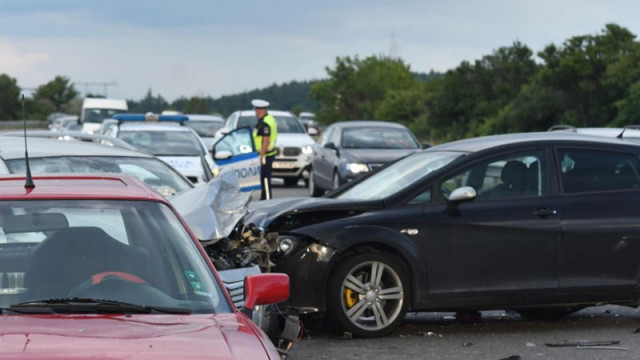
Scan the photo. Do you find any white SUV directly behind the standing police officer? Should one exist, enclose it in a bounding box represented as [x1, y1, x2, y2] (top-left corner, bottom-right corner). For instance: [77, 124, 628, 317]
[218, 110, 315, 186]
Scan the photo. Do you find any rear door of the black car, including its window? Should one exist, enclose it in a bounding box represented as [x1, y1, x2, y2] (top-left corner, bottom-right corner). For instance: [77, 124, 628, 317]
[556, 147, 640, 292]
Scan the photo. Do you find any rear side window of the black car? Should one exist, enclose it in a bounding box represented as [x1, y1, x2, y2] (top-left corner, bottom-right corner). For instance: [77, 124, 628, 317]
[558, 149, 640, 193]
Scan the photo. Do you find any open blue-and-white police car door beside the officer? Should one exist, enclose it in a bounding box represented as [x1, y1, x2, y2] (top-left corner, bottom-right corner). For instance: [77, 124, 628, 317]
[213, 127, 262, 191]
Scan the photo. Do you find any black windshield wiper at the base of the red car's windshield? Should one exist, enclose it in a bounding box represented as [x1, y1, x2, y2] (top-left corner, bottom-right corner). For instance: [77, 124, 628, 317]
[8, 298, 192, 314]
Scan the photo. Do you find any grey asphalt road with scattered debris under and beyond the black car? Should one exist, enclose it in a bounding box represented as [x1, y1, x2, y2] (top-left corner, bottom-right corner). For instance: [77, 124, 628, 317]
[264, 179, 640, 360]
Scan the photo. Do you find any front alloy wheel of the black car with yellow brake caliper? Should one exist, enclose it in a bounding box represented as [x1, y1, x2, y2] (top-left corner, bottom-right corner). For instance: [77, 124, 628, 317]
[327, 253, 409, 338]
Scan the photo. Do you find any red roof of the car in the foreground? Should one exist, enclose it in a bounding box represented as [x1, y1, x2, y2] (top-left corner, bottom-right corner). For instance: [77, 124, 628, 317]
[0, 173, 167, 203]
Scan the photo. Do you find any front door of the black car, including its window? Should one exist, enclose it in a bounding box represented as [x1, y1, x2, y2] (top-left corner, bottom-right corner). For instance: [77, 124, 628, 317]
[423, 149, 560, 297]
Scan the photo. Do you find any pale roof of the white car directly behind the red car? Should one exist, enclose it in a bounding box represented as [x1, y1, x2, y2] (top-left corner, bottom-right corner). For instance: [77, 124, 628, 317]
[0, 136, 153, 160]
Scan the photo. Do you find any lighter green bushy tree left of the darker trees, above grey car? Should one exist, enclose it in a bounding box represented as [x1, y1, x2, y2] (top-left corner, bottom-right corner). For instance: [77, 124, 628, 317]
[309, 56, 418, 124]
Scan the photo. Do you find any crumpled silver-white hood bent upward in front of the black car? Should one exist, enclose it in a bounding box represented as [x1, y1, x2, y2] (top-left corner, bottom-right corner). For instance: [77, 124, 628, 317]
[169, 170, 251, 242]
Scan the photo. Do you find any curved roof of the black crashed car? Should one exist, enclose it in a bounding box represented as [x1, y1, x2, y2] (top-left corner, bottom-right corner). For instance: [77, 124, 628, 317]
[425, 131, 638, 152]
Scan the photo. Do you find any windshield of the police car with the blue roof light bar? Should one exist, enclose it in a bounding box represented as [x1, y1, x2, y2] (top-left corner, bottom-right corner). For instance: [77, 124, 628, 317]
[118, 130, 204, 156]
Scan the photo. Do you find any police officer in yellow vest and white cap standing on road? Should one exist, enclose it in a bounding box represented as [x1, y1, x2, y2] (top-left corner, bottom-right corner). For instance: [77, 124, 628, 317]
[251, 99, 278, 200]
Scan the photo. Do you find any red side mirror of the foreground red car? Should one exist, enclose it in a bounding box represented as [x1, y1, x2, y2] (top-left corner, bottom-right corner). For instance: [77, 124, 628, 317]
[244, 273, 289, 310]
